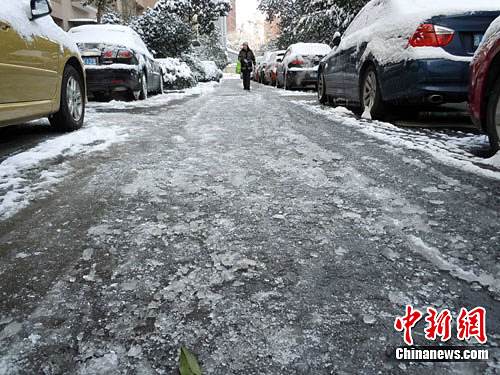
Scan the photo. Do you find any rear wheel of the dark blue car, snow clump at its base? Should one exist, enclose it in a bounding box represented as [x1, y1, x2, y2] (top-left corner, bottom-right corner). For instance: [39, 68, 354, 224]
[360, 66, 384, 120]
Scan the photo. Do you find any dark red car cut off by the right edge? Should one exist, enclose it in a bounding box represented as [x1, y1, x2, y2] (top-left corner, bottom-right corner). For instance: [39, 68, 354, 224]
[469, 17, 500, 152]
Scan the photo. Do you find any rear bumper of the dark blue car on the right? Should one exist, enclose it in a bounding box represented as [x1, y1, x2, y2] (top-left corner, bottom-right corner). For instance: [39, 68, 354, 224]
[381, 59, 470, 104]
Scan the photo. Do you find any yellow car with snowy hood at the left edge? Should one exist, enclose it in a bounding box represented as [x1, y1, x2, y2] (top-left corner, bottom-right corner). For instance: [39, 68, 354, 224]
[0, 0, 86, 131]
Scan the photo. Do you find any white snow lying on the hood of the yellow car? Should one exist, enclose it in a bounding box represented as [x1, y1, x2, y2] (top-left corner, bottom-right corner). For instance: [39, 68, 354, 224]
[0, 0, 79, 53]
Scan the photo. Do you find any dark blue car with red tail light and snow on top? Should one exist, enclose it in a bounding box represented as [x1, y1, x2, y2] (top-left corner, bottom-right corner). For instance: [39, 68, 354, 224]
[318, 0, 500, 119]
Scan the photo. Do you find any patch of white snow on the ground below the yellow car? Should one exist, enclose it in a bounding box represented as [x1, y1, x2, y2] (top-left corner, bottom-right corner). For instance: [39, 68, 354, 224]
[0, 124, 127, 220]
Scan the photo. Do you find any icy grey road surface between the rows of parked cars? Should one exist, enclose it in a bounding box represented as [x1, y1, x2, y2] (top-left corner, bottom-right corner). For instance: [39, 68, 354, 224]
[0, 80, 500, 375]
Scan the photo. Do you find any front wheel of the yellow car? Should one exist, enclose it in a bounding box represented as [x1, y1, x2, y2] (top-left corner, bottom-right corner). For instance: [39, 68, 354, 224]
[49, 65, 85, 131]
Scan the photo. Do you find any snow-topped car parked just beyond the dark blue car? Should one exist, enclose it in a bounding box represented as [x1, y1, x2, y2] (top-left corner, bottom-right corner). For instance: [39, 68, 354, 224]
[276, 43, 331, 90]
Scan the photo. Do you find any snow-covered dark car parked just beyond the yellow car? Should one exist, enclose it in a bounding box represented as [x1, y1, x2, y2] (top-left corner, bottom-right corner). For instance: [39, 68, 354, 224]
[69, 25, 163, 100]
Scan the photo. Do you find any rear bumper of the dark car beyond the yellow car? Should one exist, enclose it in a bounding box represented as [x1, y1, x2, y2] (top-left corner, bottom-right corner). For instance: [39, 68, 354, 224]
[85, 68, 141, 95]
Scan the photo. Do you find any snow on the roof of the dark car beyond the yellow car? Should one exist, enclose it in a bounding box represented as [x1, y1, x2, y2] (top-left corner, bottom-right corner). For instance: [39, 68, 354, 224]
[69, 25, 152, 57]
